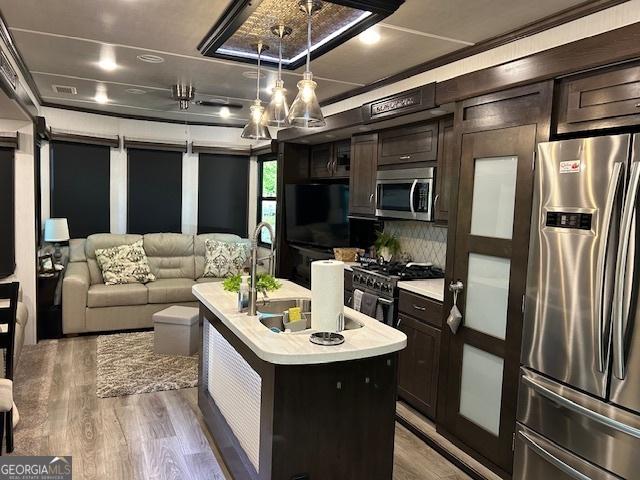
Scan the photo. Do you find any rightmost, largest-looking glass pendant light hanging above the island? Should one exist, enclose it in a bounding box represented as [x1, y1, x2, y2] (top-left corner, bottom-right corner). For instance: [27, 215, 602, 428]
[289, 0, 326, 128]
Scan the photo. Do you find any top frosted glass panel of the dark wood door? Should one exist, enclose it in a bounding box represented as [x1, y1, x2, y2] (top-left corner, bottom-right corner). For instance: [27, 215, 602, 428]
[471, 157, 518, 239]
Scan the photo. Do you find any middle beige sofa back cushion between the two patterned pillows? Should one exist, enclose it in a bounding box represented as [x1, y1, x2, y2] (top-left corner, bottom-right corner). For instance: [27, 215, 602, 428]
[144, 233, 195, 280]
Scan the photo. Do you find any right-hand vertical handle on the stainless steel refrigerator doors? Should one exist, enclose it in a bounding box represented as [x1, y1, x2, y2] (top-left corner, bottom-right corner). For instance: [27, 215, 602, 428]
[613, 162, 640, 380]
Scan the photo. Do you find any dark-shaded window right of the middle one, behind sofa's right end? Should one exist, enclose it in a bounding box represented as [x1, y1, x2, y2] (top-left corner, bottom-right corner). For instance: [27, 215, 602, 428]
[198, 153, 249, 237]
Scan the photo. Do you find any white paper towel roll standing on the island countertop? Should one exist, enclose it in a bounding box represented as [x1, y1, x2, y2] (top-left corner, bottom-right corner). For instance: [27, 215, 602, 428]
[311, 260, 344, 332]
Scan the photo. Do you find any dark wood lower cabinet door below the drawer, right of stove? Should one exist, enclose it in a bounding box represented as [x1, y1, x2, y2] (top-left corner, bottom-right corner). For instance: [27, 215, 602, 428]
[398, 315, 440, 419]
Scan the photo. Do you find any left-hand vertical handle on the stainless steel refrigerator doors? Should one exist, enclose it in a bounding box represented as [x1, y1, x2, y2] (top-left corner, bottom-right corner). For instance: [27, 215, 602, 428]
[595, 162, 622, 372]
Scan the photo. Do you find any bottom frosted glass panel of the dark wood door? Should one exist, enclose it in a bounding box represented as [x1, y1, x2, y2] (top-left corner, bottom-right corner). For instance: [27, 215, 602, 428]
[460, 345, 504, 436]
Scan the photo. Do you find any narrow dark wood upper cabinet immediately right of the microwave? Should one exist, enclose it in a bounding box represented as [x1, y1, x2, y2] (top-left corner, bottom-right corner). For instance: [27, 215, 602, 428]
[433, 118, 455, 223]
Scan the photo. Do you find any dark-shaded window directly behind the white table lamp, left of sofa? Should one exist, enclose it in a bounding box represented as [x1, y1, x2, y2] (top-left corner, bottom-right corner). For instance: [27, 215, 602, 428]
[50, 141, 111, 238]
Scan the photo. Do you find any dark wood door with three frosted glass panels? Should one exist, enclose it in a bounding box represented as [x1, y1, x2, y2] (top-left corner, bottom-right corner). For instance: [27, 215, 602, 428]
[438, 125, 536, 473]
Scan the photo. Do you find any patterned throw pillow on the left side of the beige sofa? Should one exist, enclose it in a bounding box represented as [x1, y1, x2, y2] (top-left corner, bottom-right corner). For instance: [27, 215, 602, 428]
[96, 240, 156, 285]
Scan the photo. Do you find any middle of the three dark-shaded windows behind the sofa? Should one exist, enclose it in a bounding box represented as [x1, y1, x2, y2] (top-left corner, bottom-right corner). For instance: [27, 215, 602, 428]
[127, 148, 182, 234]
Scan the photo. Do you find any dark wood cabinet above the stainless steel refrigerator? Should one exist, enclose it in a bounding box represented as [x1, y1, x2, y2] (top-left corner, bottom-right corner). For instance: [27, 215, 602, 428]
[557, 64, 640, 133]
